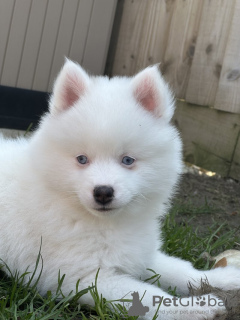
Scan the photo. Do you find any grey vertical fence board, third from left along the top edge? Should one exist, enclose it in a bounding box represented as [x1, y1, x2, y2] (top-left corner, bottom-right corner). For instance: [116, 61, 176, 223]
[17, 0, 48, 89]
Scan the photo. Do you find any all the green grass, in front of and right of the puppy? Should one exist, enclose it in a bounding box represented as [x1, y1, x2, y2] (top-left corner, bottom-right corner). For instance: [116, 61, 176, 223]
[0, 203, 240, 320]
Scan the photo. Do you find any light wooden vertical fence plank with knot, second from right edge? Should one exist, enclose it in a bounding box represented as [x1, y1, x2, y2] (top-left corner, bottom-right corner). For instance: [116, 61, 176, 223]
[186, 0, 235, 105]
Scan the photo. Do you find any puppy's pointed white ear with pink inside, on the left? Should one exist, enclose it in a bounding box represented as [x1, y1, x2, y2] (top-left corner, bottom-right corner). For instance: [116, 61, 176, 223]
[50, 59, 90, 114]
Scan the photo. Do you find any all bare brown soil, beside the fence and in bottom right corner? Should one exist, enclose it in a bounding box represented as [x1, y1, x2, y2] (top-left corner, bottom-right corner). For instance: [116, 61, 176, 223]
[174, 167, 240, 320]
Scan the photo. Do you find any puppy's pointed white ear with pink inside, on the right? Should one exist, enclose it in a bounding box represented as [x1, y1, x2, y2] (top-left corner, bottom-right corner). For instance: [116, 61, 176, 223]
[132, 65, 174, 121]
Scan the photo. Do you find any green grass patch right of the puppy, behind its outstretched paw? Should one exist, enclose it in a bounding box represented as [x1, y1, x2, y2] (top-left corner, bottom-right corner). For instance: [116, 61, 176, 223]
[163, 203, 239, 270]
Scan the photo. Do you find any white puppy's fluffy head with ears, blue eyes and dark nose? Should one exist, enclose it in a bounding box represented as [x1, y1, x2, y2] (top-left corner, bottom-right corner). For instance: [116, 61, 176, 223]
[30, 60, 181, 216]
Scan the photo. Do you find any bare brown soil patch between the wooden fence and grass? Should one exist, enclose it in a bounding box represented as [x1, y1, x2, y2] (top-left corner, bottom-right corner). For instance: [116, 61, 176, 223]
[174, 167, 240, 238]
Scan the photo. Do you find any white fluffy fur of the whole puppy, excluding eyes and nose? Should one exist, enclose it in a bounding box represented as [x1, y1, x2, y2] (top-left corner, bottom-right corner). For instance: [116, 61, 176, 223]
[0, 61, 240, 320]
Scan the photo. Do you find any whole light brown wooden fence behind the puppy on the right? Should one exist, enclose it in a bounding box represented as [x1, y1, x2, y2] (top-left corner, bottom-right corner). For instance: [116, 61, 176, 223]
[108, 0, 240, 179]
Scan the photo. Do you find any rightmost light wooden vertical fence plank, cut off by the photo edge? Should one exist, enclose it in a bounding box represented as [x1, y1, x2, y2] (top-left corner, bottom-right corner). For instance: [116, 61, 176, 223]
[214, 1, 240, 113]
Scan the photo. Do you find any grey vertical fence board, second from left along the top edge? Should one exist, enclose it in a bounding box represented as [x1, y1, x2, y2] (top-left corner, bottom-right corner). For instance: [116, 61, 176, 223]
[1, 0, 32, 87]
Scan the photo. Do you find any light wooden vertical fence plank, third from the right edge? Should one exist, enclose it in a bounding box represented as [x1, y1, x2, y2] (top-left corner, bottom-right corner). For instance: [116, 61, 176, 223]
[161, 0, 203, 98]
